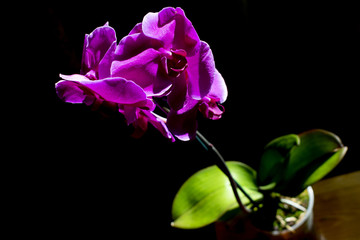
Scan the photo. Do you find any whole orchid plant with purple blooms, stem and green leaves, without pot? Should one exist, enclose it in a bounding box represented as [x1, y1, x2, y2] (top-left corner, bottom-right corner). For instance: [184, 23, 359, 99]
[55, 7, 347, 234]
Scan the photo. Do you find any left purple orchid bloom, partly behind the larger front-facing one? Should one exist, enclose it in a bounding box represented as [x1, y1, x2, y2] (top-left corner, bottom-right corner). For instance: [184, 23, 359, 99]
[56, 23, 174, 141]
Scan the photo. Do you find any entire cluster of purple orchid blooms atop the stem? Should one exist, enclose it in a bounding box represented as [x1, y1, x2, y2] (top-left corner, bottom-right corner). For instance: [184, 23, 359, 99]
[56, 7, 227, 141]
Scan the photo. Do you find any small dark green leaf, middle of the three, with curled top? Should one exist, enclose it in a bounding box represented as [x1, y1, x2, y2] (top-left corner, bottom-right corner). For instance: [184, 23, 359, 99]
[258, 134, 300, 190]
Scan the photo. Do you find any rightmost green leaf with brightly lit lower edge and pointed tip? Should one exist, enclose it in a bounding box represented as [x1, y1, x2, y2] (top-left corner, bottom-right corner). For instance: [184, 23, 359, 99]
[274, 129, 347, 196]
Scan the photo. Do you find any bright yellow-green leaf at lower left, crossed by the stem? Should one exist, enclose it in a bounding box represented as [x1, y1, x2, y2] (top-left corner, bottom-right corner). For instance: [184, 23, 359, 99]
[172, 162, 262, 229]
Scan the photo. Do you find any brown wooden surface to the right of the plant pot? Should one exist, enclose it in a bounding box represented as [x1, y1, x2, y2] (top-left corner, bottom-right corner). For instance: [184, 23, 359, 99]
[313, 171, 360, 240]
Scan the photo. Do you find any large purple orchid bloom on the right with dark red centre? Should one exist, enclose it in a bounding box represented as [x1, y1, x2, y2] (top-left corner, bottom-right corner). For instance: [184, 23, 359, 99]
[111, 7, 227, 141]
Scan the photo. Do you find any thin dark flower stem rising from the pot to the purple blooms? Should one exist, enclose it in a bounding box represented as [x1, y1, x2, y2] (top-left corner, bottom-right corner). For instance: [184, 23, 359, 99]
[196, 131, 254, 212]
